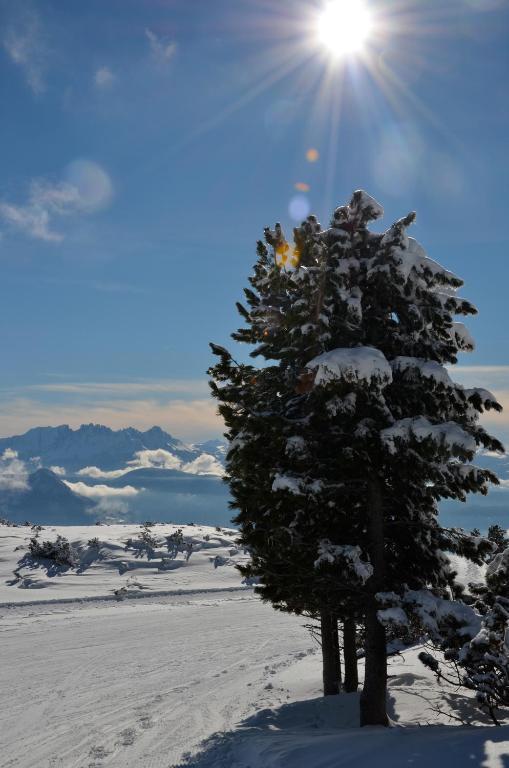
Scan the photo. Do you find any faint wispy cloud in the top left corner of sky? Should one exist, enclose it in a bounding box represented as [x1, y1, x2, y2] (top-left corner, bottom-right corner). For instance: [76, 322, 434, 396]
[2, 6, 47, 95]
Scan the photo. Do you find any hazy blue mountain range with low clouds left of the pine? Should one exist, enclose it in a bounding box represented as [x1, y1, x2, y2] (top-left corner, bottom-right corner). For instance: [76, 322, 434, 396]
[0, 424, 230, 525]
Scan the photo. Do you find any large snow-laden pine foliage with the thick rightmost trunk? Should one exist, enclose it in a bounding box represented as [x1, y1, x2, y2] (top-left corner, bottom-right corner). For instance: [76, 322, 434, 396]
[211, 191, 501, 724]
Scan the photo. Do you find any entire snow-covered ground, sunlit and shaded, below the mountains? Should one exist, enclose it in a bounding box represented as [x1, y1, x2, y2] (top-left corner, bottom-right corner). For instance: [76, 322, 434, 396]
[0, 525, 509, 768]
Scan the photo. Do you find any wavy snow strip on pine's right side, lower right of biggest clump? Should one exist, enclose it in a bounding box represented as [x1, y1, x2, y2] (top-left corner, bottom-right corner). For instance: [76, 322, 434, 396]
[380, 416, 476, 453]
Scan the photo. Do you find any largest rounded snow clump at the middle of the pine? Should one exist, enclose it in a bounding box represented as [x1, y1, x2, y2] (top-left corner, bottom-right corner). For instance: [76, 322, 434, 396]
[306, 347, 392, 385]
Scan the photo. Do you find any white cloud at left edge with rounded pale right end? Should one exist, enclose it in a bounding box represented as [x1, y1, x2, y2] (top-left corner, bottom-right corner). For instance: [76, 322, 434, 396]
[0, 160, 113, 243]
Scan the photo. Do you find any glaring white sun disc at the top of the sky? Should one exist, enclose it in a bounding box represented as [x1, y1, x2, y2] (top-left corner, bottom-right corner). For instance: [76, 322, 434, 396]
[317, 0, 373, 58]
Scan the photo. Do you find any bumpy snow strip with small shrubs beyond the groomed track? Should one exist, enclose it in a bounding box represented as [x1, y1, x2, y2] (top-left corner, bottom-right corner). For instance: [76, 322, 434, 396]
[0, 524, 248, 605]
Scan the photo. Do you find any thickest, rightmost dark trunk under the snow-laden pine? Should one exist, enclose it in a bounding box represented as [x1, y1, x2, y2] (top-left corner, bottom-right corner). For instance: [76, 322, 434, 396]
[360, 477, 389, 725]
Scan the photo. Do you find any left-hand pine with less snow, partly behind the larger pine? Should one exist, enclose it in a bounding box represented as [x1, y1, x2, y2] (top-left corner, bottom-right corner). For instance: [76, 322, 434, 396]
[211, 217, 359, 694]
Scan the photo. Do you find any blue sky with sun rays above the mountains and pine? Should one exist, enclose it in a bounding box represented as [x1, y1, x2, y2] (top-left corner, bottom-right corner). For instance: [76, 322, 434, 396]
[0, 0, 509, 439]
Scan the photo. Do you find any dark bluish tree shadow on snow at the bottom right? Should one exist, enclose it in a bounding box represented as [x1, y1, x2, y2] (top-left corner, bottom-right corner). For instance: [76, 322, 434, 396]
[168, 694, 509, 768]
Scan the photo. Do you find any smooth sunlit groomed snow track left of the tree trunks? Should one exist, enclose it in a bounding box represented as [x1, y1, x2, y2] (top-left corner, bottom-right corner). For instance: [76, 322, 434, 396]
[0, 594, 310, 768]
